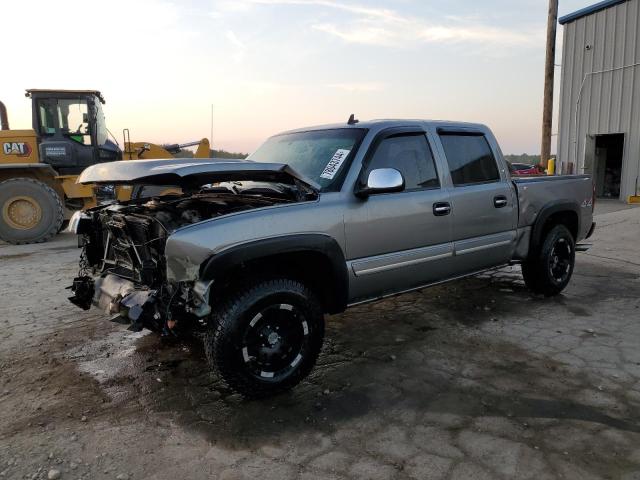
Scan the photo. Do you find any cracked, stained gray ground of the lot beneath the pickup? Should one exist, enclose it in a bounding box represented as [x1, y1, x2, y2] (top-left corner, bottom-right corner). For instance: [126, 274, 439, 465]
[0, 203, 640, 480]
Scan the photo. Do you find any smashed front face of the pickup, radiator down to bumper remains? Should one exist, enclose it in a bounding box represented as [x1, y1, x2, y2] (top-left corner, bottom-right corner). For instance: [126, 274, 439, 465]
[69, 204, 216, 333]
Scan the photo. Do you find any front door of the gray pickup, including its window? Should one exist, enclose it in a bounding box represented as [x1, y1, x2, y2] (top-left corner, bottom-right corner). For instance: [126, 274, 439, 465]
[345, 129, 453, 302]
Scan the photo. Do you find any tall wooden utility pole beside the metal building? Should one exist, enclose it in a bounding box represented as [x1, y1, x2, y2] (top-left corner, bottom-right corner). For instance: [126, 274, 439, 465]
[540, 0, 558, 172]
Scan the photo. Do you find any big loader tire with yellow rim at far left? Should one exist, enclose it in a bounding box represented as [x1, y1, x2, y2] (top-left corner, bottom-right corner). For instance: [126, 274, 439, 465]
[0, 178, 64, 245]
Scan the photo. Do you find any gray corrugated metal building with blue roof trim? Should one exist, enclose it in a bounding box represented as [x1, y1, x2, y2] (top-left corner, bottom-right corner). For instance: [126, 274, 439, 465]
[557, 0, 640, 200]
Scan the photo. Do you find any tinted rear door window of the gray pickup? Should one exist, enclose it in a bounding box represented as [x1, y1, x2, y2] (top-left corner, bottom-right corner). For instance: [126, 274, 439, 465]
[440, 133, 500, 186]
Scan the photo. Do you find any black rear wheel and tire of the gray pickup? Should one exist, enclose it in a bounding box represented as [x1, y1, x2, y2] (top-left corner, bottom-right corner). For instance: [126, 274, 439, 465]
[522, 225, 576, 297]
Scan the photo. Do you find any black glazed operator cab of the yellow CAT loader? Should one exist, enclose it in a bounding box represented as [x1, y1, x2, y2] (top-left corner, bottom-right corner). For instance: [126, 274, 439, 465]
[26, 90, 122, 175]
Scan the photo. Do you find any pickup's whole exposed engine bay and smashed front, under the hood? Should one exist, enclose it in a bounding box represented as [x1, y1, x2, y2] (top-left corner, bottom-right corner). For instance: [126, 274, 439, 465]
[69, 185, 308, 335]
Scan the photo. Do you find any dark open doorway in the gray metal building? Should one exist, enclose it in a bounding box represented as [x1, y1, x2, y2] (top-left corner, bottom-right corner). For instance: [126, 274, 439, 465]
[585, 133, 624, 198]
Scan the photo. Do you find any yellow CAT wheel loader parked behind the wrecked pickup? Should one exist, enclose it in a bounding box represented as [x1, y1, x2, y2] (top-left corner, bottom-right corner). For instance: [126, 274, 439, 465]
[0, 89, 210, 244]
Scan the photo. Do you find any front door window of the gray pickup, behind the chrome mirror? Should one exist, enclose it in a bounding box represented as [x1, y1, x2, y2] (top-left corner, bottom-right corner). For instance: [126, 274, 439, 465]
[364, 133, 440, 190]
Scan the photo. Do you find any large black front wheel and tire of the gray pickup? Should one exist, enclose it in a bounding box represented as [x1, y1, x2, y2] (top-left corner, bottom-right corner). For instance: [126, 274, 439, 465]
[204, 278, 324, 398]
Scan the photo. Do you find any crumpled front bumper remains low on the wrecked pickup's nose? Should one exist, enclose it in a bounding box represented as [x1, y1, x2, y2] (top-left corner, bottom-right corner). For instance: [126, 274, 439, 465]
[69, 274, 212, 331]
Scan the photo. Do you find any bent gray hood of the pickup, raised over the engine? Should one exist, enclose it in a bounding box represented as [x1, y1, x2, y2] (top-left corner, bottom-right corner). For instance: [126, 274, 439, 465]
[77, 158, 320, 191]
